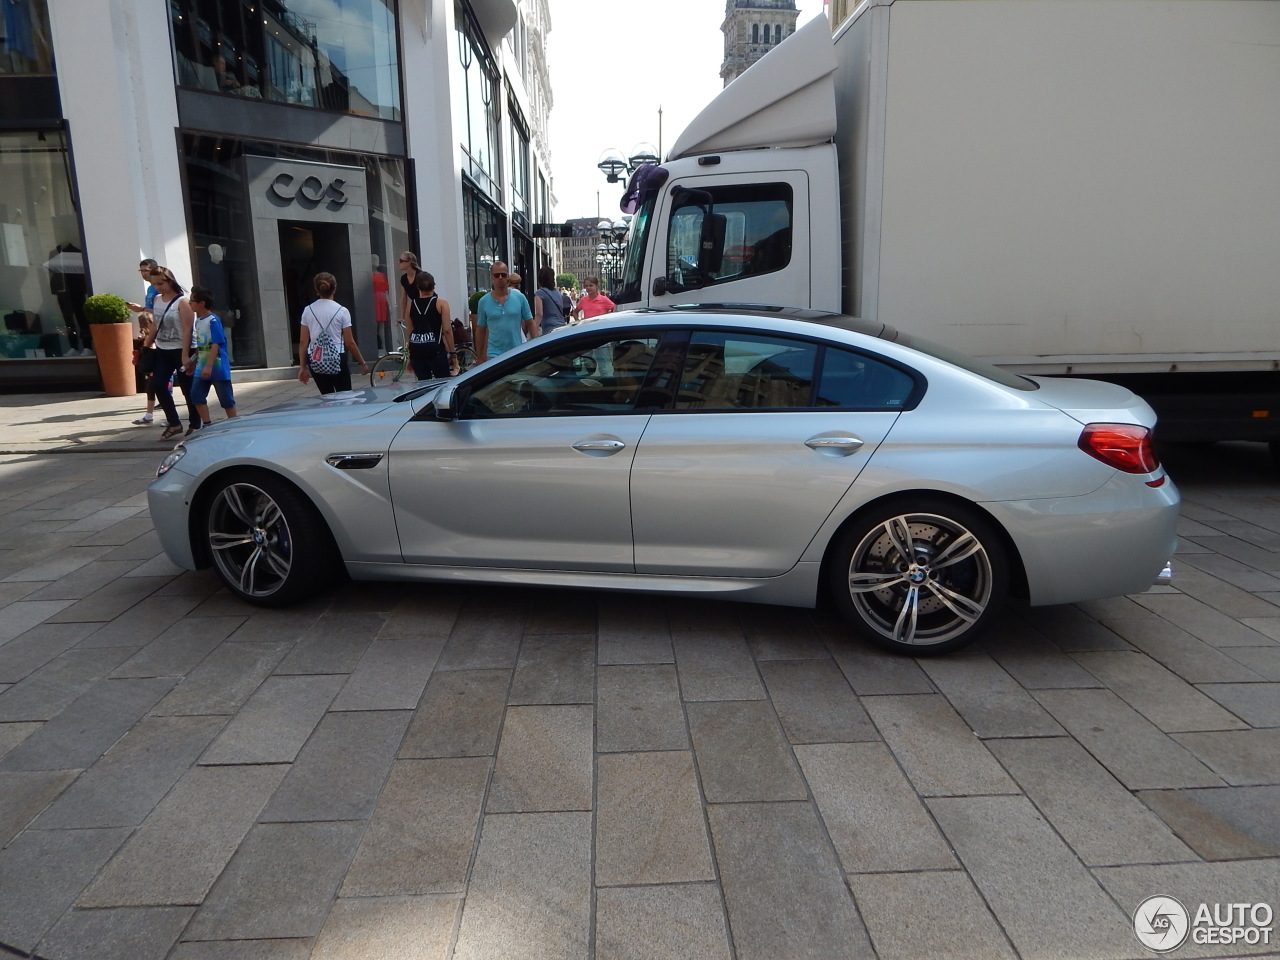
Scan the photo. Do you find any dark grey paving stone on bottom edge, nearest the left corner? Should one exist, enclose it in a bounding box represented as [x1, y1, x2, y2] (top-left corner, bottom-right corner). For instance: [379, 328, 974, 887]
[40, 906, 196, 960]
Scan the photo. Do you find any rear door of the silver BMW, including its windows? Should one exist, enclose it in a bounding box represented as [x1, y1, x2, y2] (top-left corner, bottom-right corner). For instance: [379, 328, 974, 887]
[631, 329, 923, 577]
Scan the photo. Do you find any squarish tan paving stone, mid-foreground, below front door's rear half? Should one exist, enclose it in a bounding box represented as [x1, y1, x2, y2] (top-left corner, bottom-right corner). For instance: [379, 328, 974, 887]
[488, 705, 594, 813]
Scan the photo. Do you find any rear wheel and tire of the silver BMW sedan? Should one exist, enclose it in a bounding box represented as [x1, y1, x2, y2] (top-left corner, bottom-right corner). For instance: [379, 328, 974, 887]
[828, 498, 1009, 657]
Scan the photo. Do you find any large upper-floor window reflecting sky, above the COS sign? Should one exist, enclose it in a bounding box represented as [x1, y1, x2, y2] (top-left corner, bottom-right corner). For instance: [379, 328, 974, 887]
[170, 0, 401, 120]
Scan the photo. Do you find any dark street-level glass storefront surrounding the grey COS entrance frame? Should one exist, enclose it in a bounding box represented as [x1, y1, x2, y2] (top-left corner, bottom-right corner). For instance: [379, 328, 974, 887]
[183, 133, 411, 366]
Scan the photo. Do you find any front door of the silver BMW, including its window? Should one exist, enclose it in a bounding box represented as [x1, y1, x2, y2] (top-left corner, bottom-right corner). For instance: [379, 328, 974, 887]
[389, 334, 658, 572]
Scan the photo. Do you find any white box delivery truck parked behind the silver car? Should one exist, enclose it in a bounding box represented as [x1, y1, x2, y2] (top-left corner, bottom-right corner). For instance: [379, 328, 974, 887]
[614, 0, 1280, 449]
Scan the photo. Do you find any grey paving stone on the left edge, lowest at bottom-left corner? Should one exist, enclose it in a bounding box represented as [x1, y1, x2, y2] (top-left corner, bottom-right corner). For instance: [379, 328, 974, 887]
[0, 827, 129, 952]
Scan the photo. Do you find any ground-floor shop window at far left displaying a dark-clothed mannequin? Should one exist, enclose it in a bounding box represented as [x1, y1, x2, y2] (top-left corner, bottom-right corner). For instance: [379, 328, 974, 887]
[0, 129, 92, 360]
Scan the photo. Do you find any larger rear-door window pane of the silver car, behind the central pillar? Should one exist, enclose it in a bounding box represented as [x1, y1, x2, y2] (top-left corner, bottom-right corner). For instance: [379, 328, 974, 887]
[676, 330, 818, 411]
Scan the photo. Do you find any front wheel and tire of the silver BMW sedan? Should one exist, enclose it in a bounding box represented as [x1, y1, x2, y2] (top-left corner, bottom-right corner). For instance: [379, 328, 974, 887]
[204, 472, 338, 607]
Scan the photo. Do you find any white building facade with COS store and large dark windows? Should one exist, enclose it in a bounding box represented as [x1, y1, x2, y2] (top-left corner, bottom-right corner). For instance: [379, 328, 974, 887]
[0, 0, 552, 389]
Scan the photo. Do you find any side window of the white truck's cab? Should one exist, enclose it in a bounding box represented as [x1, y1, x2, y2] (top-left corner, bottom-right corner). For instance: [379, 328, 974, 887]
[667, 183, 794, 291]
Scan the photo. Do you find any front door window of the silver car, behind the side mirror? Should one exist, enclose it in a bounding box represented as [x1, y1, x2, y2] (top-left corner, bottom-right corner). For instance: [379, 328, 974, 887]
[461, 335, 658, 420]
